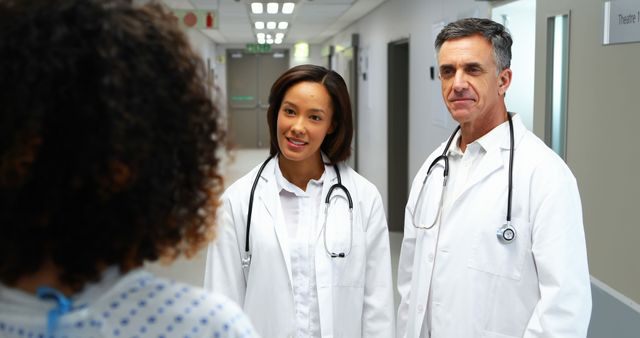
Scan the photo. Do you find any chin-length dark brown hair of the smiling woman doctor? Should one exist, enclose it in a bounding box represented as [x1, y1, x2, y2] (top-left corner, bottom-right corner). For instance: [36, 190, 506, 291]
[267, 65, 353, 163]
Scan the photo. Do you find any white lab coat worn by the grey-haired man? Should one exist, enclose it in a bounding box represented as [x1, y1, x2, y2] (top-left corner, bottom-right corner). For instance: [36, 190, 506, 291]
[397, 115, 591, 338]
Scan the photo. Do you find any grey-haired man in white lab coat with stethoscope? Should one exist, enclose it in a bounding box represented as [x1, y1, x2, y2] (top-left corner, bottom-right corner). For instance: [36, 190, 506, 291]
[397, 18, 591, 338]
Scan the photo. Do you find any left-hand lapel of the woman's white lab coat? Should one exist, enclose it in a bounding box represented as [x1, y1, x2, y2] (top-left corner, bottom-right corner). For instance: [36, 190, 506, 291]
[258, 158, 292, 286]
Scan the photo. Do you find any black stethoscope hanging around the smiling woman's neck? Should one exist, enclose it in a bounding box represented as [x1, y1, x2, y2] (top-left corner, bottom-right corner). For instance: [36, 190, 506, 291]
[241, 155, 353, 269]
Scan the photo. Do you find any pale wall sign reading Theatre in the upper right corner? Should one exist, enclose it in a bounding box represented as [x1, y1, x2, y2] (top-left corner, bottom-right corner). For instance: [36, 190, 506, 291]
[602, 0, 640, 45]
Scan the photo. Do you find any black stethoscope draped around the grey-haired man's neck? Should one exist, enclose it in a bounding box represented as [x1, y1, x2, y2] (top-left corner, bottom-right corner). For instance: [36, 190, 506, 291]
[413, 113, 516, 244]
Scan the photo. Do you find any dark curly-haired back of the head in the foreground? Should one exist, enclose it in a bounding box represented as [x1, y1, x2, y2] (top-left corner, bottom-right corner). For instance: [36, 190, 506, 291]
[0, 0, 221, 290]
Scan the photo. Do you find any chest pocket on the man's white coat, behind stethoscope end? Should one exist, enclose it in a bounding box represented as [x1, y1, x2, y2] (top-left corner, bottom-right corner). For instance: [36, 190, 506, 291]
[468, 218, 531, 280]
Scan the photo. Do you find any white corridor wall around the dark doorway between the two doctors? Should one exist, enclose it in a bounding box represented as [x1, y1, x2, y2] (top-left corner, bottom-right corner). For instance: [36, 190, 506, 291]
[324, 0, 489, 211]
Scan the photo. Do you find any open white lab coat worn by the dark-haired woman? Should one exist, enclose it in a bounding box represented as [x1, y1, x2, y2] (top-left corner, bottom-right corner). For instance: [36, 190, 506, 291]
[205, 159, 395, 338]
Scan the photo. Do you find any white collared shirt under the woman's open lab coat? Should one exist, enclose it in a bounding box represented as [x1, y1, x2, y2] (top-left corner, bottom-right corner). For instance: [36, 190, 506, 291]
[275, 161, 326, 338]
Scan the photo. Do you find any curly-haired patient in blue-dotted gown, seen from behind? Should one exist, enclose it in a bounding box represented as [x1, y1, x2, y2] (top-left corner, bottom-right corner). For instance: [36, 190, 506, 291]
[0, 0, 256, 337]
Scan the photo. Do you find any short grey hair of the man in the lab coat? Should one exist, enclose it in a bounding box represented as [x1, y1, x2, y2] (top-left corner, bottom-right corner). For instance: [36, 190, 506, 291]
[435, 18, 513, 72]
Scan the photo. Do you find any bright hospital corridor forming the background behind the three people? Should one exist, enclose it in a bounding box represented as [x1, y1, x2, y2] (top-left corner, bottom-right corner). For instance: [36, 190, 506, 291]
[144, 0, 640, 338]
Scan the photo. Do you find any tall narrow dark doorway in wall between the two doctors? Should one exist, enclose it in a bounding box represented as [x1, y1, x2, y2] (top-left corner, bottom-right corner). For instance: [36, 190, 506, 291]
[387, 39, 410, 232]
